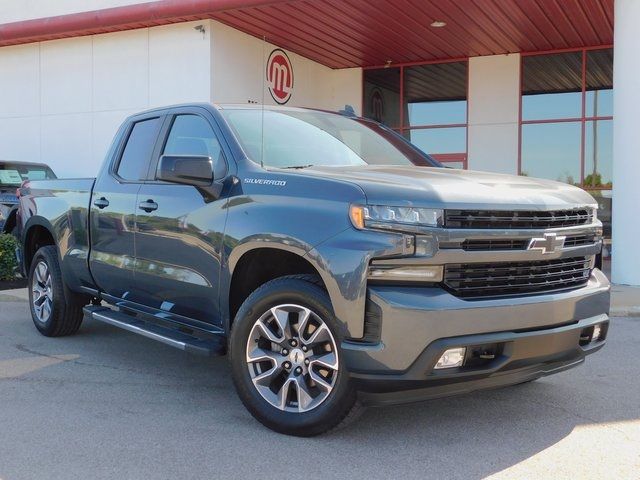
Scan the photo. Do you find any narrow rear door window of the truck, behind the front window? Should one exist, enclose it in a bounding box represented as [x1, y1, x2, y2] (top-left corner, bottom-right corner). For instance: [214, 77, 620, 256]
[117, 118, 160, 181]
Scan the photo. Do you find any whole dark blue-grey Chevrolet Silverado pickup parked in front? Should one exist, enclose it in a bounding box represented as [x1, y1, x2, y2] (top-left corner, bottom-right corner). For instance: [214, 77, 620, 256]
[20, 104, 610, 436]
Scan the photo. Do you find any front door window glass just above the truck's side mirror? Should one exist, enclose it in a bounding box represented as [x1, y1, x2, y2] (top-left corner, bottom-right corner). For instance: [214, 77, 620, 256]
[163, 115, 227, 179]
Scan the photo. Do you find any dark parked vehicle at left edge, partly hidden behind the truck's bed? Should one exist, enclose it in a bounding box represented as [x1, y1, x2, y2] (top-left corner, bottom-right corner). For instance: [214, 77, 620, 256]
[0, 160, 56, 236]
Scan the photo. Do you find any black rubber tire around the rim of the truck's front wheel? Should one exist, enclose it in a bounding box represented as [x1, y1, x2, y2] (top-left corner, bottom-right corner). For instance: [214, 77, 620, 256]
[229, 276, 356, 437]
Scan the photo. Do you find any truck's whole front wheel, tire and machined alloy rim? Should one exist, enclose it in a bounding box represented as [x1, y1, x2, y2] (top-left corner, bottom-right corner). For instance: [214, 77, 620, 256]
[229, 277, 356, 436]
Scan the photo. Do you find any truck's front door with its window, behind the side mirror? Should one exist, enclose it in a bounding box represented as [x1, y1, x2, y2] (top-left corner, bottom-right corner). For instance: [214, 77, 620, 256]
[135, 113, 227, 325]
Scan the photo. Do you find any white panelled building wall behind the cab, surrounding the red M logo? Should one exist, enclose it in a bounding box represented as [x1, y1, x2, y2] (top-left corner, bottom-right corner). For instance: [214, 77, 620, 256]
[0, 16, 362, 176]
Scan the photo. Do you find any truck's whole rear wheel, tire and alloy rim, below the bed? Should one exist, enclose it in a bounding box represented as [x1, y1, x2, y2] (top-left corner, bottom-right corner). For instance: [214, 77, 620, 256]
[29, 245, 90, 337]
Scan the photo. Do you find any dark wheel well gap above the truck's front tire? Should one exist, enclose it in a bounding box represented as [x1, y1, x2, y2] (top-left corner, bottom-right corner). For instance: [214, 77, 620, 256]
[229, 248, 322, 321]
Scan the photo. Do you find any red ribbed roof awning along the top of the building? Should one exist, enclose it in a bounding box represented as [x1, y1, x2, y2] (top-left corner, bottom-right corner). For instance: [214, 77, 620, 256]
[0, 0, 614, 68]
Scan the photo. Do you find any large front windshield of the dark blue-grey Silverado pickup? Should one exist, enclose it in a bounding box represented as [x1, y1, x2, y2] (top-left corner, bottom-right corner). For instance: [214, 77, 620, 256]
[222, 108, 439, 168]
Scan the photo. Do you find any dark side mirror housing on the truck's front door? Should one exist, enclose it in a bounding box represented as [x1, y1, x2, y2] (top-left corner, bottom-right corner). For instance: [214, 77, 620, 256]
[156, 155, 213, 187]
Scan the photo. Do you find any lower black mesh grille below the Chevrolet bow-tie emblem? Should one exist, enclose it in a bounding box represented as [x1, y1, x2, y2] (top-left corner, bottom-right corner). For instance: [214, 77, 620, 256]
[444, 257, 591, 299]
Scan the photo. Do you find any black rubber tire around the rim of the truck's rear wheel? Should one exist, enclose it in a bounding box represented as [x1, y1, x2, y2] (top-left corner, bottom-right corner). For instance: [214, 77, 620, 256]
[28, 245, 90, 337]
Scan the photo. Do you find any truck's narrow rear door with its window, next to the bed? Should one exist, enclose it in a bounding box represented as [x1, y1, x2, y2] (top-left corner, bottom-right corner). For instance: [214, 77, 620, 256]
[89, 116, 165, 299]
